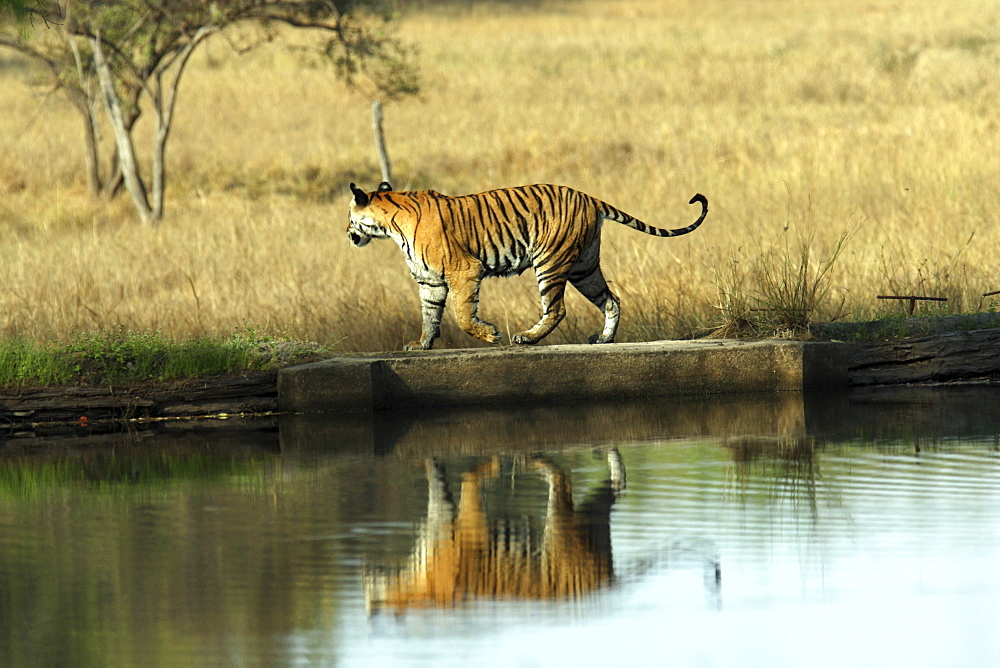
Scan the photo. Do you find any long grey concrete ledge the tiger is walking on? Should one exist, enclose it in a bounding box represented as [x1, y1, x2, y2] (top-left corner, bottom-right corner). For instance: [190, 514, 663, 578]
[278, 339, 848, 412]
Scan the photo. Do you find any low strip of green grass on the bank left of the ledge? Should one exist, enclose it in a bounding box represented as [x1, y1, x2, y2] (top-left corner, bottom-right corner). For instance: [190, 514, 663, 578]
[0, 331, 317, 387]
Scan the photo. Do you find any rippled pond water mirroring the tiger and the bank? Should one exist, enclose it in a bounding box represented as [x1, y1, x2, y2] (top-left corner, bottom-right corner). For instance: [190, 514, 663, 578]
[0, 387, 1000, 666]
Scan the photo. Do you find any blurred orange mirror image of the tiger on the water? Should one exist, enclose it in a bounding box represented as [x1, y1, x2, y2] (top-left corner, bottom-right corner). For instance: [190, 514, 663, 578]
[365, 449, 625, 613]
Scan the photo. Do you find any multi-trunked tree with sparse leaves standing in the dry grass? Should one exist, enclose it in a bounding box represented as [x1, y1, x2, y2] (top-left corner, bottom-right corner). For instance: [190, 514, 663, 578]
[0, 0, 418, 222]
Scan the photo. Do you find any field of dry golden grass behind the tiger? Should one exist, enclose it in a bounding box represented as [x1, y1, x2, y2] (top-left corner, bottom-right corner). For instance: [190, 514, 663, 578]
[0, 0, 1000, 350]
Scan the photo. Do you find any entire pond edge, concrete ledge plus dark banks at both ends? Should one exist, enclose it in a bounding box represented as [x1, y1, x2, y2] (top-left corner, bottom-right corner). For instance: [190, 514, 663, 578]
[0, 314, 1000, 431]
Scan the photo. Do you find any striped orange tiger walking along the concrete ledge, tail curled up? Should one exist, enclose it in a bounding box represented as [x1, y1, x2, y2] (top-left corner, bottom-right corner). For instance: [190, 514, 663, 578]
[347, 181, 708, 350]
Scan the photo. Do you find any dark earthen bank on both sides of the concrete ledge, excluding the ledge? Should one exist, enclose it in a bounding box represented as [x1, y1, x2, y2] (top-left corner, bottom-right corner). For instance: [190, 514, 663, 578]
[0, 314, 1000, 433]
